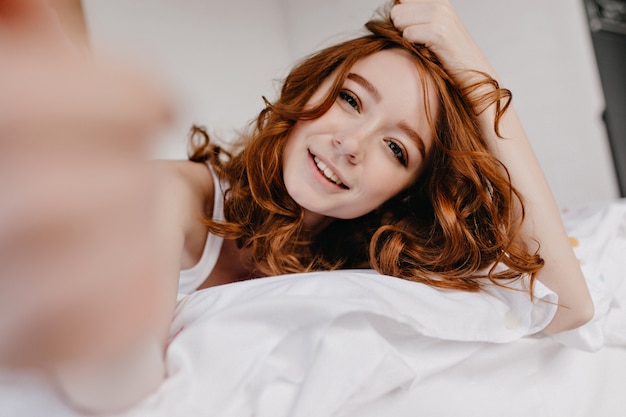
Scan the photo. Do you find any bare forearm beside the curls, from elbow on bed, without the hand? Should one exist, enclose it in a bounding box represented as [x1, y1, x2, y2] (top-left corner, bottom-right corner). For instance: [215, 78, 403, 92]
[470, 65, 593, 333]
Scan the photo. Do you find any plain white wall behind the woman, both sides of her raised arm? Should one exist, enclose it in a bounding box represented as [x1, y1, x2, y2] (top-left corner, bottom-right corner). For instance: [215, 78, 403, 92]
[83, 0, 617, 207]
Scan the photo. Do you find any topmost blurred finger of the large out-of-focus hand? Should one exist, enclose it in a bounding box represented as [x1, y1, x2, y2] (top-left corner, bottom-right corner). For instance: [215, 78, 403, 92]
[0, 56, 171, 141]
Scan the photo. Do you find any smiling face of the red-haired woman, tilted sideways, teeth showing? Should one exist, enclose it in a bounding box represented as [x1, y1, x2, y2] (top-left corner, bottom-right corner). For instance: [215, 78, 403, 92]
[283, 49, 437, 226]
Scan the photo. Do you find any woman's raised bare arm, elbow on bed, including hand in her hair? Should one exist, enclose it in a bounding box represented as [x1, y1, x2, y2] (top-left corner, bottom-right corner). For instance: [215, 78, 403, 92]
[391, 0, 593, 333]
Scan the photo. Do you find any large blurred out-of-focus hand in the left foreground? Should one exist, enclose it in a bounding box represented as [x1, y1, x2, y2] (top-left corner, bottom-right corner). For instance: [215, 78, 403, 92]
[0, 0, 173, 410]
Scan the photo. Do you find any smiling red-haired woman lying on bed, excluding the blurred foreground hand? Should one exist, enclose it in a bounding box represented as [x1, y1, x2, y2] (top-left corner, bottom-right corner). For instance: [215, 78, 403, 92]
[0, 0, 593, 409]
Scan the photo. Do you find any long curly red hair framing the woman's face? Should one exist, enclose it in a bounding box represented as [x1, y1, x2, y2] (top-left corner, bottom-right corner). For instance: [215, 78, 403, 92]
[189, 6, 543, 291]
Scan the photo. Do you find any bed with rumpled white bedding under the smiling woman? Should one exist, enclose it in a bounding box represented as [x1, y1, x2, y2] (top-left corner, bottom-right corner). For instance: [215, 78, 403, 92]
[0, 200, 626, 417]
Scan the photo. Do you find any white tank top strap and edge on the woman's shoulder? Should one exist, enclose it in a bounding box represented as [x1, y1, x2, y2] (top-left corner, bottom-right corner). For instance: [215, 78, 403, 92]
[178, 164, 227, 294]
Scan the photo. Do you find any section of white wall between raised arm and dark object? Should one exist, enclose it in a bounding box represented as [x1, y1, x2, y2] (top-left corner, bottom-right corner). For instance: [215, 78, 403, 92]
[446, 0, 618, 206]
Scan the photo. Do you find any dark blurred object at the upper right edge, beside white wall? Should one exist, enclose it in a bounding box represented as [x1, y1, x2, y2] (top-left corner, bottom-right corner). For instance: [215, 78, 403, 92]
[584, 0, 626, 197]
